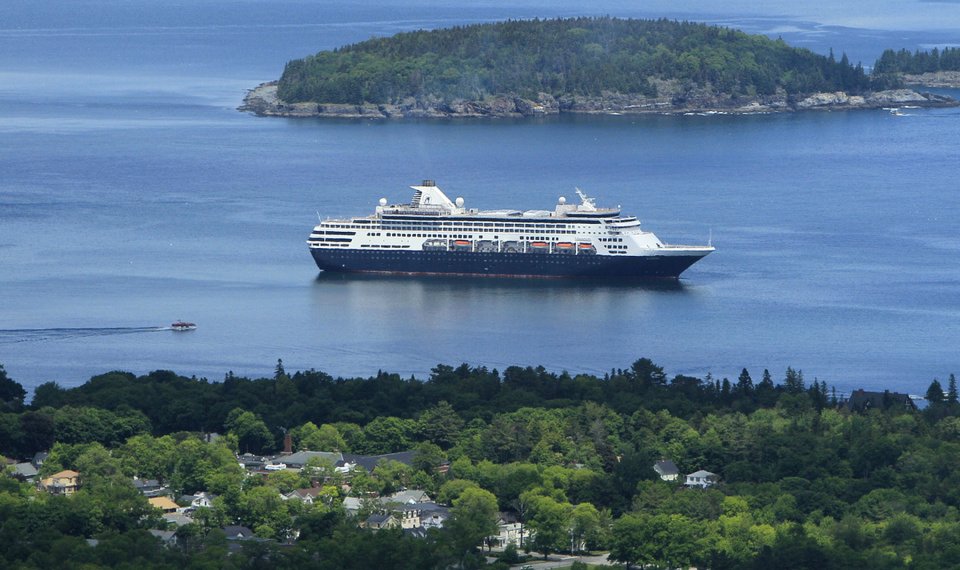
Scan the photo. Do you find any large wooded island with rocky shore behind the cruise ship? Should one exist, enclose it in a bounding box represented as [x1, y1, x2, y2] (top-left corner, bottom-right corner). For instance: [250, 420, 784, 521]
[241, 17, 957, 118]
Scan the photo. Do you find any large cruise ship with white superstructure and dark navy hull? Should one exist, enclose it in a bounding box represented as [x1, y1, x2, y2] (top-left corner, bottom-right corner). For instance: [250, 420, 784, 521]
[307, 180, 714, 279]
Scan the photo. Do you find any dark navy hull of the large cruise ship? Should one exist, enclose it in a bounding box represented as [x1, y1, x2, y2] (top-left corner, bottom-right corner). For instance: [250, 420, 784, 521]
[310, 248, 709, 279]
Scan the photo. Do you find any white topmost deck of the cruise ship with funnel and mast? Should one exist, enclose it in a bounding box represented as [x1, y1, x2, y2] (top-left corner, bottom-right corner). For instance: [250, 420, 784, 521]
[374, 180, 624, 221]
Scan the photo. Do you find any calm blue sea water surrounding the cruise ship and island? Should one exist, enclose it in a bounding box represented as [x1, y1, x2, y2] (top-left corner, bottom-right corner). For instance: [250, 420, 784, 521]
[0, 0, 960, 393]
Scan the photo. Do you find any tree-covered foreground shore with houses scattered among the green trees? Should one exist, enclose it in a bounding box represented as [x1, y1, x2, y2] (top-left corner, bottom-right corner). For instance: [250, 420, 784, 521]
[0, 359, 960, 570]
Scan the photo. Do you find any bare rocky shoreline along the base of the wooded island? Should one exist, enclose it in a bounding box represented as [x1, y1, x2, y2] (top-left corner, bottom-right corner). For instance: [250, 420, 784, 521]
[239, 80, 960, 119]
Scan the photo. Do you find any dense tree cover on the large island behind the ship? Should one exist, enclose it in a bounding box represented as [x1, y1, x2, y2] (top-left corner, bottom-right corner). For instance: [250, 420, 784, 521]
[278, 17, 872, 104]
